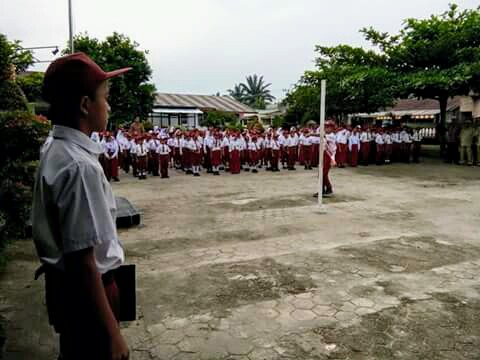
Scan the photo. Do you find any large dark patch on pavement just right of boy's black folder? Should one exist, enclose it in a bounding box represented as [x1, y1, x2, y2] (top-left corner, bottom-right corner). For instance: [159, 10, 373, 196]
[140, 258, 314, 321]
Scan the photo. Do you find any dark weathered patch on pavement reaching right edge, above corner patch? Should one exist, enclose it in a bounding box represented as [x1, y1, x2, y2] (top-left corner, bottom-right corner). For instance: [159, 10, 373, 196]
[338, 236, 480, 273]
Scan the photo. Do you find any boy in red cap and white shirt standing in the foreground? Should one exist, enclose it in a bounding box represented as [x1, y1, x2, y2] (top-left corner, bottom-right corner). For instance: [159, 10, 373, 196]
[32, 53, 129, 360]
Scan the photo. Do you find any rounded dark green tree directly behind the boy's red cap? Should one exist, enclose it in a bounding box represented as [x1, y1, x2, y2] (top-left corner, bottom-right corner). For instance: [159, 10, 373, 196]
[66, 32, 155, 125]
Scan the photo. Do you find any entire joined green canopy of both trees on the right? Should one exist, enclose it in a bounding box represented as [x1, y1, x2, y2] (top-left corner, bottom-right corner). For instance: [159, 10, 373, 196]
[285, 5, 480, 123]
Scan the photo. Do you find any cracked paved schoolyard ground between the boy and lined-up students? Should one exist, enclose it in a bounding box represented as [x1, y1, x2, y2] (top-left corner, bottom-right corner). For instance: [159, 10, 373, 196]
[0, 160, 480, 360]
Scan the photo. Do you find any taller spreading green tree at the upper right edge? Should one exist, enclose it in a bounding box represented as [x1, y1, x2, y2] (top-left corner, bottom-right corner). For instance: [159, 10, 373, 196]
[362, 4, 480, 126]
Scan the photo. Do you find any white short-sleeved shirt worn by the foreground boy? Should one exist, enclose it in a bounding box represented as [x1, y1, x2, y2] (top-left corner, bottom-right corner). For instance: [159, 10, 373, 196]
[32, 125, 124, 274]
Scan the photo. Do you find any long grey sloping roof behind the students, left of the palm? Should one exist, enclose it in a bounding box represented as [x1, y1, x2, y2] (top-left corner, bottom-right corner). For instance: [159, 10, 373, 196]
[154, 93, 256, 113]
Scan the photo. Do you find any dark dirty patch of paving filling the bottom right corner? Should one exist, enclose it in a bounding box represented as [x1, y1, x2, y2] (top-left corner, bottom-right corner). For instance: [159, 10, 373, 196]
[281, 293, 480, 360]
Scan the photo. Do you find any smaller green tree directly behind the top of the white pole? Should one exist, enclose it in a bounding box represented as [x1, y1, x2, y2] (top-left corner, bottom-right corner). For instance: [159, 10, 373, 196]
[285, 45, 397, 124]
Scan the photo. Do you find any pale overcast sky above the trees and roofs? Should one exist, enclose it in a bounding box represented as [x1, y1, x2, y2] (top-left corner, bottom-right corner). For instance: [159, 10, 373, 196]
[0, 0, 479, 97]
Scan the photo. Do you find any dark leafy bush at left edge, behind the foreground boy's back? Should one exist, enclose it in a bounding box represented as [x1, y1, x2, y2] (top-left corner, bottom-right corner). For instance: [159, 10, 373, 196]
[0, 111, 50, 248]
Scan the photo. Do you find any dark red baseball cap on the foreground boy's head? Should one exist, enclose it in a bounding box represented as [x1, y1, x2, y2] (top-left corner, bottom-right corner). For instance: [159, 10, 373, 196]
[42, 52, 132, 103]
